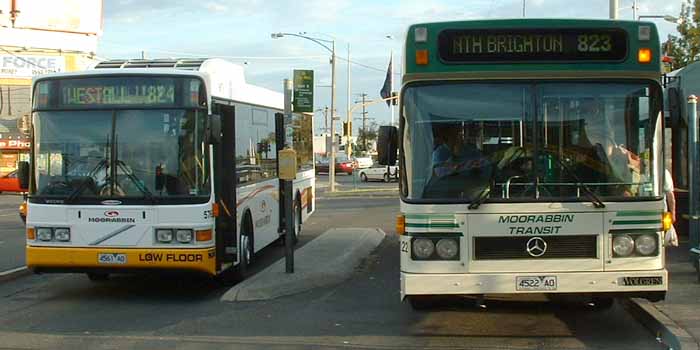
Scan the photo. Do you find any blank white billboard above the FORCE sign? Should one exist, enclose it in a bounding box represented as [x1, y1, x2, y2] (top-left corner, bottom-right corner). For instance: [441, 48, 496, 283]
[13, 0, 102, 35]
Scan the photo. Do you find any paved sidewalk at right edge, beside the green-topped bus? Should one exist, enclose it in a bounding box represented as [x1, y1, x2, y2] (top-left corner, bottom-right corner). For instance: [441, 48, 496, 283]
[647, 242, 700, 350]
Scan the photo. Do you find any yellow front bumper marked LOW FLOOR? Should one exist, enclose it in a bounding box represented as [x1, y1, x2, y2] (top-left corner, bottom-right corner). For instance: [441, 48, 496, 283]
[26, 246, 216, 275]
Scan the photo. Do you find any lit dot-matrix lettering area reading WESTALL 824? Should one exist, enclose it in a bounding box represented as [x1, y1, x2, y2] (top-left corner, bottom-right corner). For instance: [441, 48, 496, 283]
[61, 81, 175, 105]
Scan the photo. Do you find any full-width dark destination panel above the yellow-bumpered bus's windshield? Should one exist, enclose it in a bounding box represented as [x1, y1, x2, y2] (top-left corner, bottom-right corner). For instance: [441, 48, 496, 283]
[34, 76, 206, 109]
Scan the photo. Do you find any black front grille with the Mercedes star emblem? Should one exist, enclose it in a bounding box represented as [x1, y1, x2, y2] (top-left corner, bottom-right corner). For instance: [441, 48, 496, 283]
[474, 235, 598, 260]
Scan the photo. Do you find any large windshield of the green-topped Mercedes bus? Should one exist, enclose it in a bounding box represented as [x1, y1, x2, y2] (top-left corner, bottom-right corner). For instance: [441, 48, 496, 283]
[402, 81, 661, 202]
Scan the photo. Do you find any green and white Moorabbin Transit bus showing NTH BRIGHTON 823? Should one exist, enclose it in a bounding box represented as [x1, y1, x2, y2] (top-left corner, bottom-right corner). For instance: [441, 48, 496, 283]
[378, 19, 671, 306]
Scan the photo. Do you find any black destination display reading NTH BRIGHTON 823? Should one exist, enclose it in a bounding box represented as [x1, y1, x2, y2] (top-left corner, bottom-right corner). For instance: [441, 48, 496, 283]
[438, 28, 628, 63]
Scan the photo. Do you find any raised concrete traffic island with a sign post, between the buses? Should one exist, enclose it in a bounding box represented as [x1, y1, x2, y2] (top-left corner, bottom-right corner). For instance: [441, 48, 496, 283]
[221, 228, 386, 301]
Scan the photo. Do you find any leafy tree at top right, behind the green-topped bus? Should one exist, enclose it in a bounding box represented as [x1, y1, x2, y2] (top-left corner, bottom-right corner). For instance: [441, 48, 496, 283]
[663, 0, 700, 70]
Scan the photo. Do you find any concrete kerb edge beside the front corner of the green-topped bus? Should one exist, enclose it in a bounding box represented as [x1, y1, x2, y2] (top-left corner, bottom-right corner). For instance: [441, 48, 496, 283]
[623, 298, 700, 350]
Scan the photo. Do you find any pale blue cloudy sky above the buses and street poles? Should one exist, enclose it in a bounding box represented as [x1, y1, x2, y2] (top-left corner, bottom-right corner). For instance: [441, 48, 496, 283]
[98, 0, 683, 135]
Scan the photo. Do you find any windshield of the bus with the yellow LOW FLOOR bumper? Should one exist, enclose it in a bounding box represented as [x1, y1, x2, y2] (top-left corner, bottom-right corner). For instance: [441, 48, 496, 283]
[33, 109, 210, 202]
